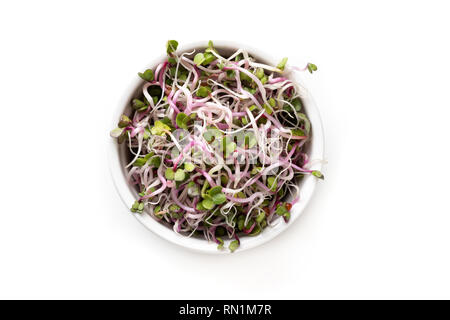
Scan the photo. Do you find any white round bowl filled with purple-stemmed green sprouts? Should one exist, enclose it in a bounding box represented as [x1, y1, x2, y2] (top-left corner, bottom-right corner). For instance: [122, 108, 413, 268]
[109, 40, 324, 253]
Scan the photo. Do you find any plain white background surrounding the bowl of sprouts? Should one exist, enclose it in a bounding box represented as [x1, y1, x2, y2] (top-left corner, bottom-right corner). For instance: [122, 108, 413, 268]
[0, 0, 450, 299]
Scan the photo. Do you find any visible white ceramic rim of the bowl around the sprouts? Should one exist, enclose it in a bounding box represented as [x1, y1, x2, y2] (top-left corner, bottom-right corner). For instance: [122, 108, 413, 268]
[109, 41, 324, 254]
